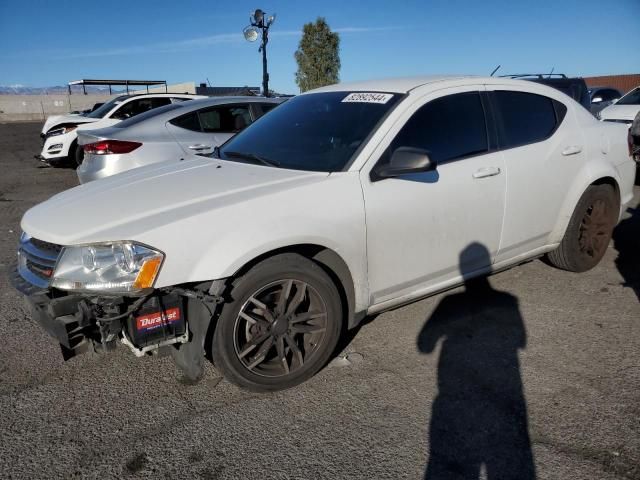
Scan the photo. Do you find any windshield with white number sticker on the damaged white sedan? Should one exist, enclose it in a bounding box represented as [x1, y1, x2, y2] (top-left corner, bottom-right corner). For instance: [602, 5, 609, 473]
[219, 92, 400, 172]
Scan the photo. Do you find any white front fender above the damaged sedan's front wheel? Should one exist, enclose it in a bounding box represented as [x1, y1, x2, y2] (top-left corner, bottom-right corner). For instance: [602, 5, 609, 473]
[152, 172, 368, 311]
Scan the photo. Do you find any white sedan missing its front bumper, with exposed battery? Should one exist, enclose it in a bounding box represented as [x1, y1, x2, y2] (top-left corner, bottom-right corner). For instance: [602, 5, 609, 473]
[13, 77, 636, 391]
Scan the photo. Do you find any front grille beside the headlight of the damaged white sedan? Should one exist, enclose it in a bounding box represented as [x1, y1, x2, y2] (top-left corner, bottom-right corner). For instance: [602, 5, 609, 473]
[18, 237, 62, 288]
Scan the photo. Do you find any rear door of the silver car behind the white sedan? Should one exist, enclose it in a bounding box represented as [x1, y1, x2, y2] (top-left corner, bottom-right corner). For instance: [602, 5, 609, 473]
[167, 104, 253, 155]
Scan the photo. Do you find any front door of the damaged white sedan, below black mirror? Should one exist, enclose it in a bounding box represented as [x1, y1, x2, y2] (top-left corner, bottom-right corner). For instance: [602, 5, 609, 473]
[361, 87, 505, 304]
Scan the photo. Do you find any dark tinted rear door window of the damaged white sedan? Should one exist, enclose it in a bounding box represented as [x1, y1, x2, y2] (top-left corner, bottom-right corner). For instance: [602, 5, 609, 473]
[493, 90, 567, 149]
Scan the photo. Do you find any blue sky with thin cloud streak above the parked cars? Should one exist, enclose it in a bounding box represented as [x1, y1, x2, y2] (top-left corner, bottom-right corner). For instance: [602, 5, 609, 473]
[0, 0, 640, 93]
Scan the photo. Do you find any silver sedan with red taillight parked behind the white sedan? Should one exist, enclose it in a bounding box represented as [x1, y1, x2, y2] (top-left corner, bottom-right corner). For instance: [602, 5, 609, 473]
[77, 97, 285, 183]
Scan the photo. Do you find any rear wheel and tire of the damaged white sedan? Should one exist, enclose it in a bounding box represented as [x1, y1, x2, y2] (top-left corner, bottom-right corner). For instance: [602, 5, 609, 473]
[547, 185, 620, 272]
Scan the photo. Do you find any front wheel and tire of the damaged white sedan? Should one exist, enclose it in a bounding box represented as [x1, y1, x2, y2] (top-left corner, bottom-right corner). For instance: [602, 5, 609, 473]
[211, 253, 343, 392]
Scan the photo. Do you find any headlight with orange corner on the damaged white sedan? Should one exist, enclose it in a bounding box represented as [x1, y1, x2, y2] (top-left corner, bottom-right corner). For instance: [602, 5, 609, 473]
[51, 242, 164, 294]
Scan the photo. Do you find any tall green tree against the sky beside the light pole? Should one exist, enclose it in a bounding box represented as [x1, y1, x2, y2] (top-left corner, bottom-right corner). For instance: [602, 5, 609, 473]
[295, 17, 340, 92]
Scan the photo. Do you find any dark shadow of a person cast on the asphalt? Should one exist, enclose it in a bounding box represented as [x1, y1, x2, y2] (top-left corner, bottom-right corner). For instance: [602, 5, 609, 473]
[417, 243, 535, 480]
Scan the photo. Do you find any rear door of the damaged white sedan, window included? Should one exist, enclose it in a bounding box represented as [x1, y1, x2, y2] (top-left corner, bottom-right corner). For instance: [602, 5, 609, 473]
[487, 85, 584, 262]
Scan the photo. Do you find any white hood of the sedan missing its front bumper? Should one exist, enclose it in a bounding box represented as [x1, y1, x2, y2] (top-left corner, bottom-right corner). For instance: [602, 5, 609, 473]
[21, 155, 329, 245]
